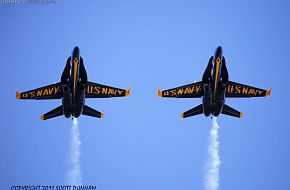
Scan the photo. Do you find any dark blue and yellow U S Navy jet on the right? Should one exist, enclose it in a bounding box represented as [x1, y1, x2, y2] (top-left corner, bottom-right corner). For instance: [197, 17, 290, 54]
[158, 46, 272, 118]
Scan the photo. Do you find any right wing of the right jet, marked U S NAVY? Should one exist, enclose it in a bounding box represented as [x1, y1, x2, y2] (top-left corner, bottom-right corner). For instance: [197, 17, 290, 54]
[226, 81, 272, 98]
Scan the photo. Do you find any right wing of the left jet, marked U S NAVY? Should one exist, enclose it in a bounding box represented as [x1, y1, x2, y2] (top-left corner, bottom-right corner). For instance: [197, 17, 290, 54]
[86, 82, 130, 98]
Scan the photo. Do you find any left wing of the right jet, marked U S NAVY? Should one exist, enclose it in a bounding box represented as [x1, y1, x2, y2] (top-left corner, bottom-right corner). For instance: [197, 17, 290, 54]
[158, 81, 203, 98]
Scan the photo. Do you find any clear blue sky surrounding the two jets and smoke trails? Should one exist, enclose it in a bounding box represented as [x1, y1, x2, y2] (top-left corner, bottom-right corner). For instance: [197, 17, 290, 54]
[0, 0, 290, 190]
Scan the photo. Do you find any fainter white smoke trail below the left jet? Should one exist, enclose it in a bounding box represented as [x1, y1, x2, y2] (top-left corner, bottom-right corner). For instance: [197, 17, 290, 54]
[67, 118, 82, 185]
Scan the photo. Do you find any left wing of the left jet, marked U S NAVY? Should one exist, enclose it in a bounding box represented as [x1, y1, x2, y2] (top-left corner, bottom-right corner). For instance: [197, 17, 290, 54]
[16, 82, 63, 100]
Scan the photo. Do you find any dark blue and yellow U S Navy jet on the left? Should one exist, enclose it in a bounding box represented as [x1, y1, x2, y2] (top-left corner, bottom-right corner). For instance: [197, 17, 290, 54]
[16, 47, 130, 120]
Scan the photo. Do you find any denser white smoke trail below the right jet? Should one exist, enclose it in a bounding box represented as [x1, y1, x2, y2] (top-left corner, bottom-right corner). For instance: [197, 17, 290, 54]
[205, 117, 221, 190]
